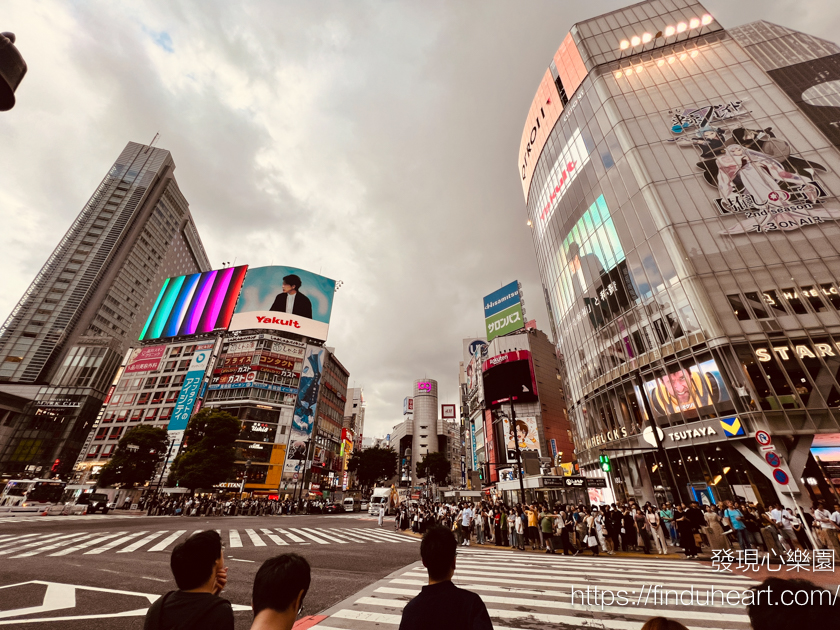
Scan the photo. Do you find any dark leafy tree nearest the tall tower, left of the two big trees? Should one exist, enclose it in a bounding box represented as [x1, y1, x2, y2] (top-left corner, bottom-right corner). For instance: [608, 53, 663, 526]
[97, 425, 168, 488]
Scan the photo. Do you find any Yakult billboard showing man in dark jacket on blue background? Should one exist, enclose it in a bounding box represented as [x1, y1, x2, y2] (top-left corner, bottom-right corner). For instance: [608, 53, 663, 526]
[230, 266, 335, 340]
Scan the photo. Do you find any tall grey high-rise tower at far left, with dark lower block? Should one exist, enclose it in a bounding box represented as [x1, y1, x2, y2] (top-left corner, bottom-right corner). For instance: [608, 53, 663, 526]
[0, 142, 210, 474]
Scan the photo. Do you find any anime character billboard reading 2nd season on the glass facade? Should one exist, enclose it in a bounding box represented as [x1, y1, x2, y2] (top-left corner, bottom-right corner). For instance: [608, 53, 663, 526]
[668, 101, 840, 235]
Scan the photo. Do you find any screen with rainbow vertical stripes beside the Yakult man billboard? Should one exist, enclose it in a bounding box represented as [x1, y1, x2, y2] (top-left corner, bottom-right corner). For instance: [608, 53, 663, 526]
[140, 265, 248, 341]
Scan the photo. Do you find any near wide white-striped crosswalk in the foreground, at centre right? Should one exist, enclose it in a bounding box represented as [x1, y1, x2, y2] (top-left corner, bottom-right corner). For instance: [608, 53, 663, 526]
[311, 548, 757, 630]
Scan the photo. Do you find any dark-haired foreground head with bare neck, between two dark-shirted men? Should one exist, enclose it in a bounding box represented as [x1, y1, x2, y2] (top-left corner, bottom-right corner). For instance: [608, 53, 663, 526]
[251, 553, 312, 630]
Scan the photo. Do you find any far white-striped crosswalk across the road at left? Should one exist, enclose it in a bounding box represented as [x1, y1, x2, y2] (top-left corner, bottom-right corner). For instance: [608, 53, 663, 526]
[0, 527, 418, 562]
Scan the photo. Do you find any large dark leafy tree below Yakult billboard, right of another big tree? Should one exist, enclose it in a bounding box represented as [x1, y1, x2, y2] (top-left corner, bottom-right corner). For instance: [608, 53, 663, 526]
[169, 409, 241, 490]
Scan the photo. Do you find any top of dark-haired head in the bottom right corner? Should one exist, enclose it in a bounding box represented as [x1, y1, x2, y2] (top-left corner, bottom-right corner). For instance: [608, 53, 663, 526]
[747, 577, 840, 630]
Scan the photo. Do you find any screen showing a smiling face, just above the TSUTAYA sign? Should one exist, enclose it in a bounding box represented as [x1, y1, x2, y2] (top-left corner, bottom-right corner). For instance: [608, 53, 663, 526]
[645, 359, 731, 418]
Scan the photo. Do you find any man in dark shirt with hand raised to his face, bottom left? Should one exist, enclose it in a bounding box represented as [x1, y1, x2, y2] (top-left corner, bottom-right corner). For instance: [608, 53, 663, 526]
[143, 529, 233, 630]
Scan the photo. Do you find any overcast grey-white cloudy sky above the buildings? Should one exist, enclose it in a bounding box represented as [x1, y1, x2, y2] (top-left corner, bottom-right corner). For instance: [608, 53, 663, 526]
[0, 0, 840, 435]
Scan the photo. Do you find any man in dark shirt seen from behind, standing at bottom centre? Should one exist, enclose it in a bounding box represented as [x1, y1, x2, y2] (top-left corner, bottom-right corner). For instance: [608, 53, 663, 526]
[399, 525, 493, 630]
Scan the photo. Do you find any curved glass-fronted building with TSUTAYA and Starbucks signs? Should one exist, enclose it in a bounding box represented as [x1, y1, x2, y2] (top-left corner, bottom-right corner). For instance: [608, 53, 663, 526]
[517, 0, 840, 503]
